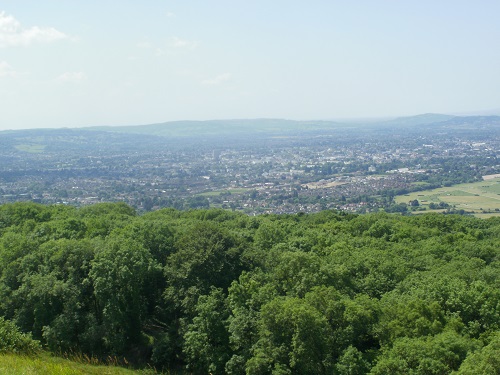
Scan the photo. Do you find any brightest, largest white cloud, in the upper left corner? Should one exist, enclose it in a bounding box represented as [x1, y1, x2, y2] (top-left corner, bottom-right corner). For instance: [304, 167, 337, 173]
[0, 12, 68, 47]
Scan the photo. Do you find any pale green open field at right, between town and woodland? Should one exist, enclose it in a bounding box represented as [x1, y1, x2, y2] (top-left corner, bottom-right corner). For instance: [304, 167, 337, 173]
[395, 178, 500, 217]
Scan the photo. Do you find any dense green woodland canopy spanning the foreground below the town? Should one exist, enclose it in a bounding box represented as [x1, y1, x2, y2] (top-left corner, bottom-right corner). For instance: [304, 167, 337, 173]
[0, 203, 500, 374]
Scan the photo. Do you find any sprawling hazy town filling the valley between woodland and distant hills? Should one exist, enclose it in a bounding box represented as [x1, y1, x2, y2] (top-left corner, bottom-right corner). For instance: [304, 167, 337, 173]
[0, 117, 500, 215]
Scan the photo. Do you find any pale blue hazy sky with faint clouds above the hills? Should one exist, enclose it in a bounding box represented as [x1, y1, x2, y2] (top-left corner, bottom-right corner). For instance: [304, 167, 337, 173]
[0, 0, 500, 130]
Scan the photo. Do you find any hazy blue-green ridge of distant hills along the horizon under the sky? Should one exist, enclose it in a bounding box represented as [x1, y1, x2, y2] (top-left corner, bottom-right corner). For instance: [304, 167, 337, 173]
[0, 113, 500, 142]
